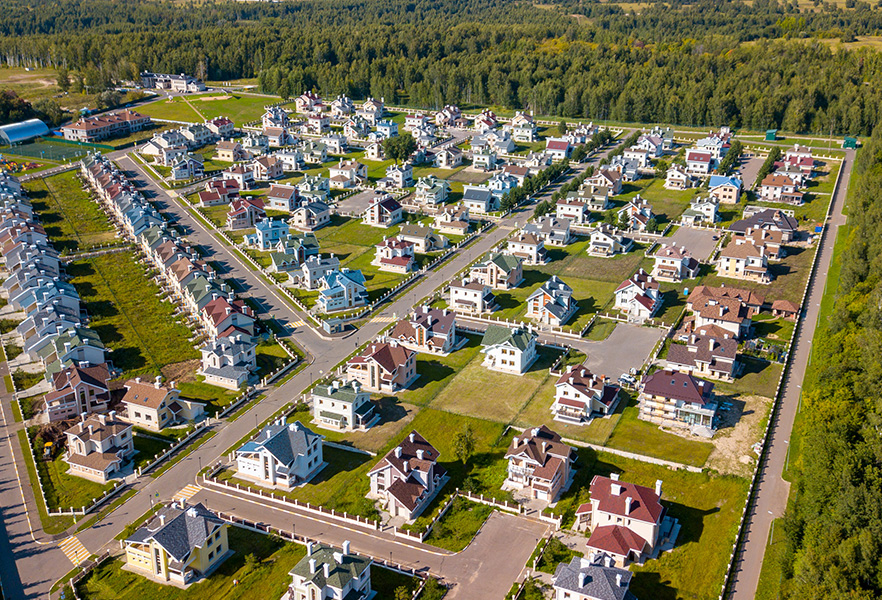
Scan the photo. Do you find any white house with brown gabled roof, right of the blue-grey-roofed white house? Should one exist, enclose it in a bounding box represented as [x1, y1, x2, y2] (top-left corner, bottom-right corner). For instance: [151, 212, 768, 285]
[368, 431, 447, 521]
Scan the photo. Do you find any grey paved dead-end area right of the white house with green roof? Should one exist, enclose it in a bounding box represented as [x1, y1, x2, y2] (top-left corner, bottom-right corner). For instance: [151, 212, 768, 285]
[576, 323, 664, 381]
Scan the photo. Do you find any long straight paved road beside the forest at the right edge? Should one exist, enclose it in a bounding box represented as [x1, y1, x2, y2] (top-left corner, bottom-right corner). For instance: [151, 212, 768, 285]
[730, 150, 854, 600]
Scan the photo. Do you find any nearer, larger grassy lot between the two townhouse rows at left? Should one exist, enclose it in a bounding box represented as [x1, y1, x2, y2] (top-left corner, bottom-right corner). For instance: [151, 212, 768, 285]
[67, 252, 199, 376]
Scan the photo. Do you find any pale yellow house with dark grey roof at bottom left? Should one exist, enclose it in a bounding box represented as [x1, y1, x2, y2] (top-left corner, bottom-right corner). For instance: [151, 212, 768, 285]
[125, 502, 232, 585]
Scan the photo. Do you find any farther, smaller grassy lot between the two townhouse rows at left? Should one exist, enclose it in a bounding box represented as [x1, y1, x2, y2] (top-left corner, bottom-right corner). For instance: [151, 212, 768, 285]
[25, 171, 116, 253]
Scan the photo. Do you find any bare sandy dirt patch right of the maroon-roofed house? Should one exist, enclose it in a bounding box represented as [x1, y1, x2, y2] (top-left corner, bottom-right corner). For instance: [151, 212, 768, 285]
[705, 396, 772, 477]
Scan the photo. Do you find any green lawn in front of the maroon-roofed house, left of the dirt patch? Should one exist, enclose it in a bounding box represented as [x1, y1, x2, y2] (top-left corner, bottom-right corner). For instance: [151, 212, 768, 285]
[606, 397, 714, 467]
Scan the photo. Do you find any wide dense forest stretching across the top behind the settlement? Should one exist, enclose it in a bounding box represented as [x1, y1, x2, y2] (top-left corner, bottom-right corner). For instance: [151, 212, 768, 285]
[0, 0, 882, 135]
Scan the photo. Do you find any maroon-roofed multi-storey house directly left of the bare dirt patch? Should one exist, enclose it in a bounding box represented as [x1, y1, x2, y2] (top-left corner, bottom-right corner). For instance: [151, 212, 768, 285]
[637, 369, 719, 431]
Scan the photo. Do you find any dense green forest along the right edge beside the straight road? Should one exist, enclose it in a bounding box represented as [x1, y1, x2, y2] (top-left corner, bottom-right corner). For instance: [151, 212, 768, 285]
[782, 132, 882, 600]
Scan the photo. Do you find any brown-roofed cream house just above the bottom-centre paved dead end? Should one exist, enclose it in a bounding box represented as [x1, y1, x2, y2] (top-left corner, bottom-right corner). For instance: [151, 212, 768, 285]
[502, 425, 576, 502]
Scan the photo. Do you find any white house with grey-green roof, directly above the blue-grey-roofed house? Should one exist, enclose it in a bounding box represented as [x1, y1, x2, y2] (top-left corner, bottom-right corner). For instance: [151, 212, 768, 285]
[312, 379, 380, 431]
